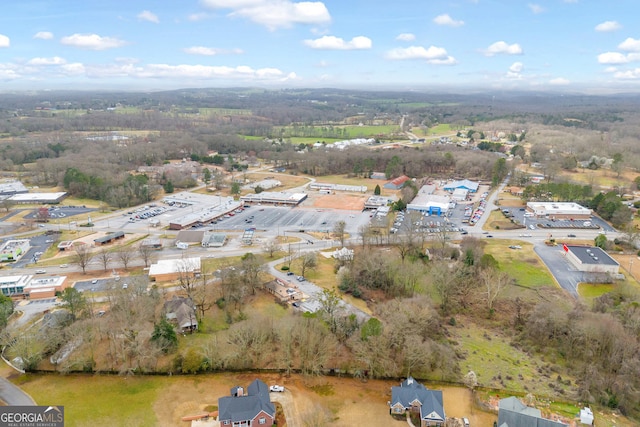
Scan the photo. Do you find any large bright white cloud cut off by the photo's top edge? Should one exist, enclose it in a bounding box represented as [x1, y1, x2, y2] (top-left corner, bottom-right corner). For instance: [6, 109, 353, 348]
[202, 0, 331, 30]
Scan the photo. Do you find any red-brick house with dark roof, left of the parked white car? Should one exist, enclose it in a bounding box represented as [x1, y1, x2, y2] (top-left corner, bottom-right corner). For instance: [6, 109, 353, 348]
[218, 379, 276, 427]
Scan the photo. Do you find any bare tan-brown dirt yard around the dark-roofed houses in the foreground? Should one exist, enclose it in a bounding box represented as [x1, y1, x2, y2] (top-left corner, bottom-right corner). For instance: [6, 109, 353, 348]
[153, 374, 496, 427]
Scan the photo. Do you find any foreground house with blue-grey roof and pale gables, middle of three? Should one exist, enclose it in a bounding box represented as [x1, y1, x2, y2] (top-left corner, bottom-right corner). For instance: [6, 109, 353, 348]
[389, 377, 446, 427]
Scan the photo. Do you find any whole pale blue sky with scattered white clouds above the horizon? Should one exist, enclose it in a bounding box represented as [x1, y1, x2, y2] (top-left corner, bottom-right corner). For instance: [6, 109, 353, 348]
[0, 0, 640, 93]
